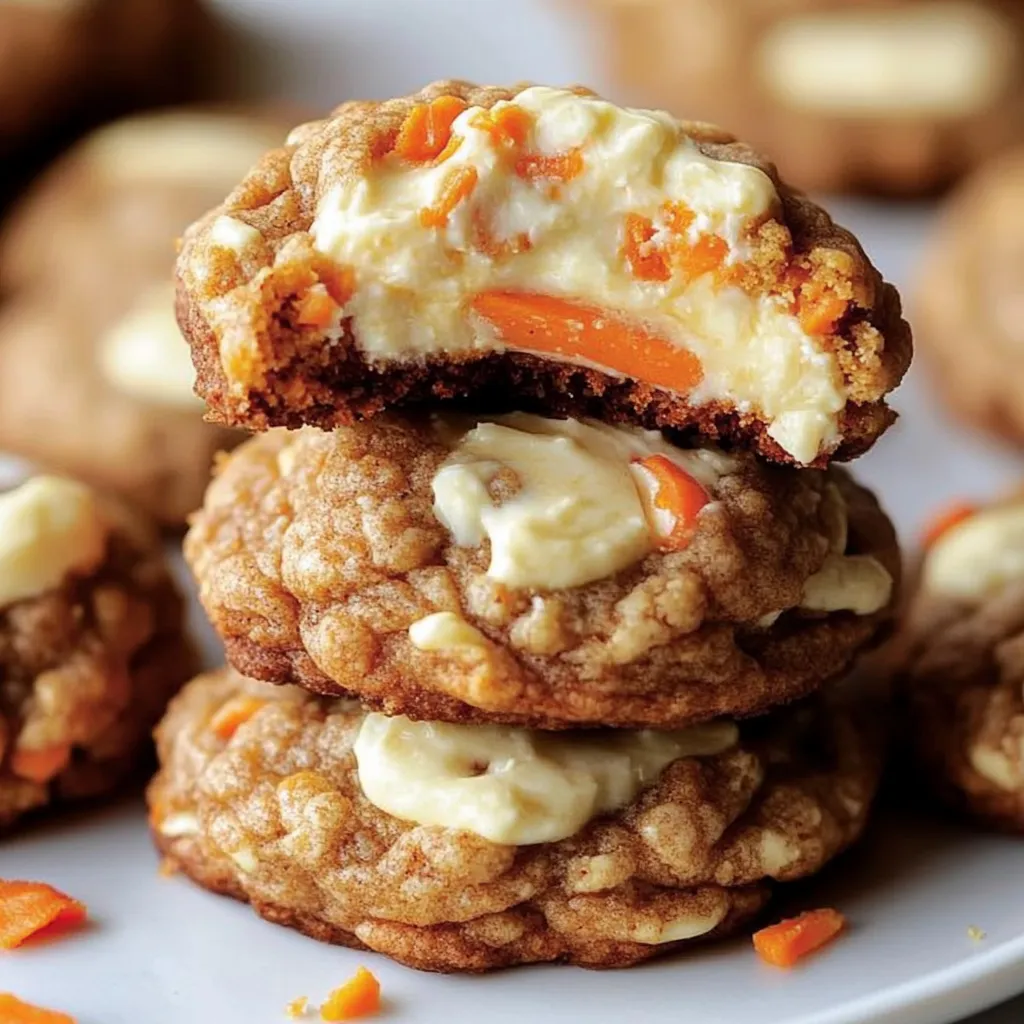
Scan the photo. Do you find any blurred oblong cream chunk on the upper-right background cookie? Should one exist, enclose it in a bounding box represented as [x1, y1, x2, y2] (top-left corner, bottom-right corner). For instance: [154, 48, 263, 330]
[755, 0, 1019, 119]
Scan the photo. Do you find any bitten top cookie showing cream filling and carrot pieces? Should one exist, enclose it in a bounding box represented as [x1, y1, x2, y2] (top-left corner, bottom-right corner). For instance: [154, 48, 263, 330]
[178, 82, 910, 465]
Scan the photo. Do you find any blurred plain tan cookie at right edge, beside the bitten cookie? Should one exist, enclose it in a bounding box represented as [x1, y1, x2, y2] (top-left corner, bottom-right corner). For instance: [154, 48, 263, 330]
[911, 147, 1024, 444]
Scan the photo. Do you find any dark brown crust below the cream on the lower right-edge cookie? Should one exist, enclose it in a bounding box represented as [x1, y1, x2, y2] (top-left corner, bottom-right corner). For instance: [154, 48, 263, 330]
[897, 583, 1024, 833]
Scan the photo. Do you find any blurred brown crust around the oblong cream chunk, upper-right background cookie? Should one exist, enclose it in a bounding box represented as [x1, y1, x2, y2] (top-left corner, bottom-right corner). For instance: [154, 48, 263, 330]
[580, 0, 1024, 193]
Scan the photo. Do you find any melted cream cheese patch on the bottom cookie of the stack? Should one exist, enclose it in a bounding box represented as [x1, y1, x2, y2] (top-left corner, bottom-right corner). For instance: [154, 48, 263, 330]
[354, 713, 738, 843]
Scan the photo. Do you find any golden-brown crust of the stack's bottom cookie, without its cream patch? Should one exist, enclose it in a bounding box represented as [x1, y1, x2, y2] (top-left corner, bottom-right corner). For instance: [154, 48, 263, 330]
[148, 670, 883, 971]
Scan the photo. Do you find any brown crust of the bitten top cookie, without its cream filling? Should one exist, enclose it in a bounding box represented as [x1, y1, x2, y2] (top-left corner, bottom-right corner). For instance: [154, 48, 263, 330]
[178, 82, 911, 465]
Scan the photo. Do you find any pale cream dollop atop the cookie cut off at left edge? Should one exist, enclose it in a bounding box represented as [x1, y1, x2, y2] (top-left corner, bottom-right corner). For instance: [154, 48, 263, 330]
[0, 476, 108, 607]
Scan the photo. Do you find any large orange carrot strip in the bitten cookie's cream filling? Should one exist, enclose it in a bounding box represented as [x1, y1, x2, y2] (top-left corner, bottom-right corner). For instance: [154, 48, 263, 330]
[472, 292, 703, 393]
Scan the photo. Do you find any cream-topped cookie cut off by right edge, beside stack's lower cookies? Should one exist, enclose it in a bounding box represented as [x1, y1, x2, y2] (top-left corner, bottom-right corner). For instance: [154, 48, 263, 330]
[897, 494, 1024, 831]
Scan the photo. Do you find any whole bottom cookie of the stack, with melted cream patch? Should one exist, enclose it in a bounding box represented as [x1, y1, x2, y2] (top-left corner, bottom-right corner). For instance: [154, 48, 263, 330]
[148, 669, 883, 971]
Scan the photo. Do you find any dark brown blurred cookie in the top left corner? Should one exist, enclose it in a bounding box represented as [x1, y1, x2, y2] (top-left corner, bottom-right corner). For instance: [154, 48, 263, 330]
[0, 0, 214, 192]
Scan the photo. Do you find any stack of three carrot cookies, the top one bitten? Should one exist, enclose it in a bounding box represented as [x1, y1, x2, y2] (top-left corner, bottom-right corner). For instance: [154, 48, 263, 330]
[150, 82, 910, 971]
